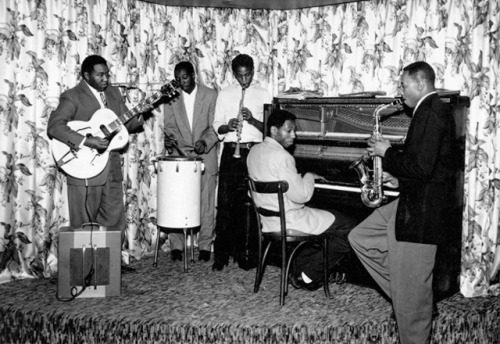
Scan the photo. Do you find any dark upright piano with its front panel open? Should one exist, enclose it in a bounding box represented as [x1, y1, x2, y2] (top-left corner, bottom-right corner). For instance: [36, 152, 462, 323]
[264, 90, 470, 299]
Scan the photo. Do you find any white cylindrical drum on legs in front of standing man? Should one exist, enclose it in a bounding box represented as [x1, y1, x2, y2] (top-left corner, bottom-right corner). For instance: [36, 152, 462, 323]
[156, 156, 205, 228]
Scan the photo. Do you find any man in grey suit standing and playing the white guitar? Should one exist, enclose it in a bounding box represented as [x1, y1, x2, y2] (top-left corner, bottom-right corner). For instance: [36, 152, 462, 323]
[47, 55, 152, 272]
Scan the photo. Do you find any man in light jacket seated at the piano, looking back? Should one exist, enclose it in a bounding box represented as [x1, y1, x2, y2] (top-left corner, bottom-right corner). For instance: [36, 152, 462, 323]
[247, 110, 357, 291]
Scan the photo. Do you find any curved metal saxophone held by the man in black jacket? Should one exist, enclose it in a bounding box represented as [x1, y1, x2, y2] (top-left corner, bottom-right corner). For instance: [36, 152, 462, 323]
[349, 99, 403, 208]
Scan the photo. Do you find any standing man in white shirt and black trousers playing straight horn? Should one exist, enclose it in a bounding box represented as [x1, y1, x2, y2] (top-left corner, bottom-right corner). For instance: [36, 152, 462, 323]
[212, 54, 272, 271]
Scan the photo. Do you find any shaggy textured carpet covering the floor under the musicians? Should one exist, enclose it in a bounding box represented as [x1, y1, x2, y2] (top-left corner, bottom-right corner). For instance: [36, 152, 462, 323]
[0, 252, 500, 344]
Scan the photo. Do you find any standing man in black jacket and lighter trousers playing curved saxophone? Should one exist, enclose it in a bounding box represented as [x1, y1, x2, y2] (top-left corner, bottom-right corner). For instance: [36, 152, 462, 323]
[349, 62, 457, 344]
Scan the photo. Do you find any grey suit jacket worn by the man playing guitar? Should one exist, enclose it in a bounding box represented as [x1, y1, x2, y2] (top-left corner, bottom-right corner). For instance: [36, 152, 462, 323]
[47, 80, 141, 186]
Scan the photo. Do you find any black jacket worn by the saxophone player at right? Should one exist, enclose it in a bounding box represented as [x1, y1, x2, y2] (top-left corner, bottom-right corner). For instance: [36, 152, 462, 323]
[382, 94, 458, 244]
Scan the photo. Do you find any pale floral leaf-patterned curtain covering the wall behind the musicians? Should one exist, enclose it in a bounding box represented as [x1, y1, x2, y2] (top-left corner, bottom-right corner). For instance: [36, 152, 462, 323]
[0, 0, 500, 297]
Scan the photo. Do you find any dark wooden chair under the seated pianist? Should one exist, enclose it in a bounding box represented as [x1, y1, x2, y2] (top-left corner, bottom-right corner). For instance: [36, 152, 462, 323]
[248, 178, 330, 305]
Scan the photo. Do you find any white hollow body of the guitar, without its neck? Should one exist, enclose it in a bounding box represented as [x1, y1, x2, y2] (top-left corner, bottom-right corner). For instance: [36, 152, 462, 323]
[52, 109, 129, 179]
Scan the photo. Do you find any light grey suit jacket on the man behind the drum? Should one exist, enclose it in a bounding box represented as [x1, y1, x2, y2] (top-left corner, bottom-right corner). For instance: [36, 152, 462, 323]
[164, 84, 219, 175]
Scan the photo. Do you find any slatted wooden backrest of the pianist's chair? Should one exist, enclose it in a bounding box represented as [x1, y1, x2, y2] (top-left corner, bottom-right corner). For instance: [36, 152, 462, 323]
[248, 177, 288, 237]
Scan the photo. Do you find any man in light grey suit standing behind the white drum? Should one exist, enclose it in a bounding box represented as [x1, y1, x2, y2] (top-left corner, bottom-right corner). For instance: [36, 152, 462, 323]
[164, 61, 219, 262]
